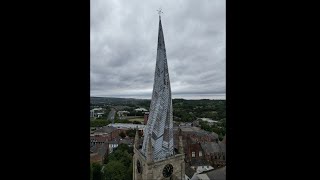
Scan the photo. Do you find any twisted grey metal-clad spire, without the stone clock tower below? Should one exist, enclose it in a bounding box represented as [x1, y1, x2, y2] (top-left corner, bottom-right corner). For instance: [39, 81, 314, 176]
[141, 19, 174, 161]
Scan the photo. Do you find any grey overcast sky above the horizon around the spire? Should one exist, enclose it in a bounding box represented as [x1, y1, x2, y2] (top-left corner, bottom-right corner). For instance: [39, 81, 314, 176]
[90, 0, 226, 99]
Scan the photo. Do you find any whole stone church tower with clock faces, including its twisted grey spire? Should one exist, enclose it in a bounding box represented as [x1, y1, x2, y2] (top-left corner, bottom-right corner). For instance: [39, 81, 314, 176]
[133, 11, 185, 180]
